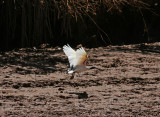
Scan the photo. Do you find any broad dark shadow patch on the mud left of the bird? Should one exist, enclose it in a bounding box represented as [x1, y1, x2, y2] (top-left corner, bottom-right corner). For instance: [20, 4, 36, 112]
[0, 49, 65, 74]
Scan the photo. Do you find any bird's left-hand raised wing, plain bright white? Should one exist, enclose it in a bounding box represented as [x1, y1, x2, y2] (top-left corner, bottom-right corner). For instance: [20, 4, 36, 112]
[63, 44, 76, 67]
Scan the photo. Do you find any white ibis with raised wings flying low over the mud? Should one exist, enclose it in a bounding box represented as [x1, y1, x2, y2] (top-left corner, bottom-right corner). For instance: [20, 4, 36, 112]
[63, 44, 94, 79]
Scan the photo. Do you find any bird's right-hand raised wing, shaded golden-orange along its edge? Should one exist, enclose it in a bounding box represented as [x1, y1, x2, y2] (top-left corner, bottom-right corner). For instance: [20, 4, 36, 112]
[76, 47, 88, 66]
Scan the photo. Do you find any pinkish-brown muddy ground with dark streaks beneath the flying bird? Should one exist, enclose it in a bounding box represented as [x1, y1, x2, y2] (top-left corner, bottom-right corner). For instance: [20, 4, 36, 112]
[0, 43, 160, 117]
